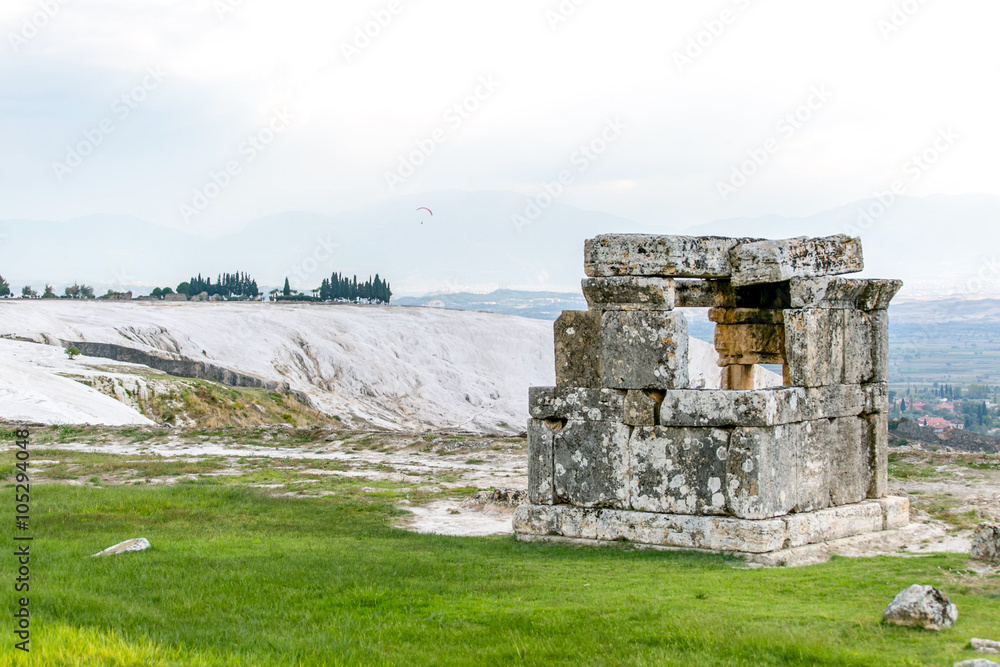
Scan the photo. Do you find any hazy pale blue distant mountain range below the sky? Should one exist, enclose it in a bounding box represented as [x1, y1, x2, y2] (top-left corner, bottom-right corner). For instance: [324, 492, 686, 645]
[0, 191, 1000, 298]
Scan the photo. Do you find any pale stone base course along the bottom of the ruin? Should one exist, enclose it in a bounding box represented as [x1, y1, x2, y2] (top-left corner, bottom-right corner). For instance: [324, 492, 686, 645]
[513, 496, 910, 555]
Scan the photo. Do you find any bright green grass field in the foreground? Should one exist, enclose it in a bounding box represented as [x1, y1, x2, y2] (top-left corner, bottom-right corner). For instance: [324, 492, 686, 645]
[0, 482, 1000, 666]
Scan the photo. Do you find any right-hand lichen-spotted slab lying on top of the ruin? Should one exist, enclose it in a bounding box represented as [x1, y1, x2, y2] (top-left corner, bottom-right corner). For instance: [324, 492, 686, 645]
[732, 234, 865, 286]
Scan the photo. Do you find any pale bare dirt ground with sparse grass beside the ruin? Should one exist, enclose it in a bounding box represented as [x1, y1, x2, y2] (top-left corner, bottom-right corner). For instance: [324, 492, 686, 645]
[9, 427, 1000, 564]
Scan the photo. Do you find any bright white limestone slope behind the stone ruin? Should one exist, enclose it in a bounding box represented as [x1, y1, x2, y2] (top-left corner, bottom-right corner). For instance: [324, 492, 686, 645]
[0, 300, 776, 431]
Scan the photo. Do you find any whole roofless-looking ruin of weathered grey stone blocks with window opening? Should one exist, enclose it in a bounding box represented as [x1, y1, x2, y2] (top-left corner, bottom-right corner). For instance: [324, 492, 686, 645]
[514, 234, 909, 557]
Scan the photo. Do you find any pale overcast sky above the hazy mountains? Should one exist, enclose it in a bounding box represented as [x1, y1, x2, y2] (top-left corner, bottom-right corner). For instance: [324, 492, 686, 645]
[0, 0, 1000, 232]
